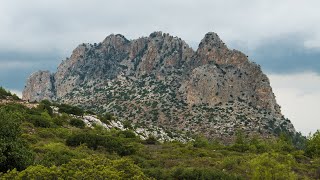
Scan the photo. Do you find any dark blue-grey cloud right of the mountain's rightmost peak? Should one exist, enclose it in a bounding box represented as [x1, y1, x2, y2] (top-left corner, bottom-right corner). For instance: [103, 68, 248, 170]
[239, 35, 320, 74]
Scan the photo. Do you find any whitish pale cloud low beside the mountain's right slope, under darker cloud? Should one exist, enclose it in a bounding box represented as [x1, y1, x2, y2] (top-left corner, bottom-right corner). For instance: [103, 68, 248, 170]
[269, 72, 320, 135]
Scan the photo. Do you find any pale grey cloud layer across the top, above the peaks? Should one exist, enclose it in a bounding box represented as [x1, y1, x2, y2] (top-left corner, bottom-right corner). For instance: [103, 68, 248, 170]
[0, 0, 320, 50]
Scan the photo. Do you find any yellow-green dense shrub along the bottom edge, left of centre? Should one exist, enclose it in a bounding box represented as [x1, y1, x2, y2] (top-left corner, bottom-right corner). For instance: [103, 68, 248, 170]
[2, 156, 149, 180]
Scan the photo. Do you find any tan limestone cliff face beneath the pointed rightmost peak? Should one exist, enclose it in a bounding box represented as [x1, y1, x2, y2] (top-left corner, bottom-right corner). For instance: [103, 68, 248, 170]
[188, 33, 281, 114]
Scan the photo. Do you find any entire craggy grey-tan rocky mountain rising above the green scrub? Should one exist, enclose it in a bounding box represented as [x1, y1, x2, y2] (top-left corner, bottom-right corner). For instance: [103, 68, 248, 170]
[23, 32, 295, 138]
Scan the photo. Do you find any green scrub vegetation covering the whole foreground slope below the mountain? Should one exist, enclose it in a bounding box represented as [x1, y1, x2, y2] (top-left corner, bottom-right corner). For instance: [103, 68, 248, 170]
[0, 88, 320, 179]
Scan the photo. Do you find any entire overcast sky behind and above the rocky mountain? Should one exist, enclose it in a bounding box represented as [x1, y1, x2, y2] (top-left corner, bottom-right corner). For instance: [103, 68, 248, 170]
[0, 0, 320, 134]
